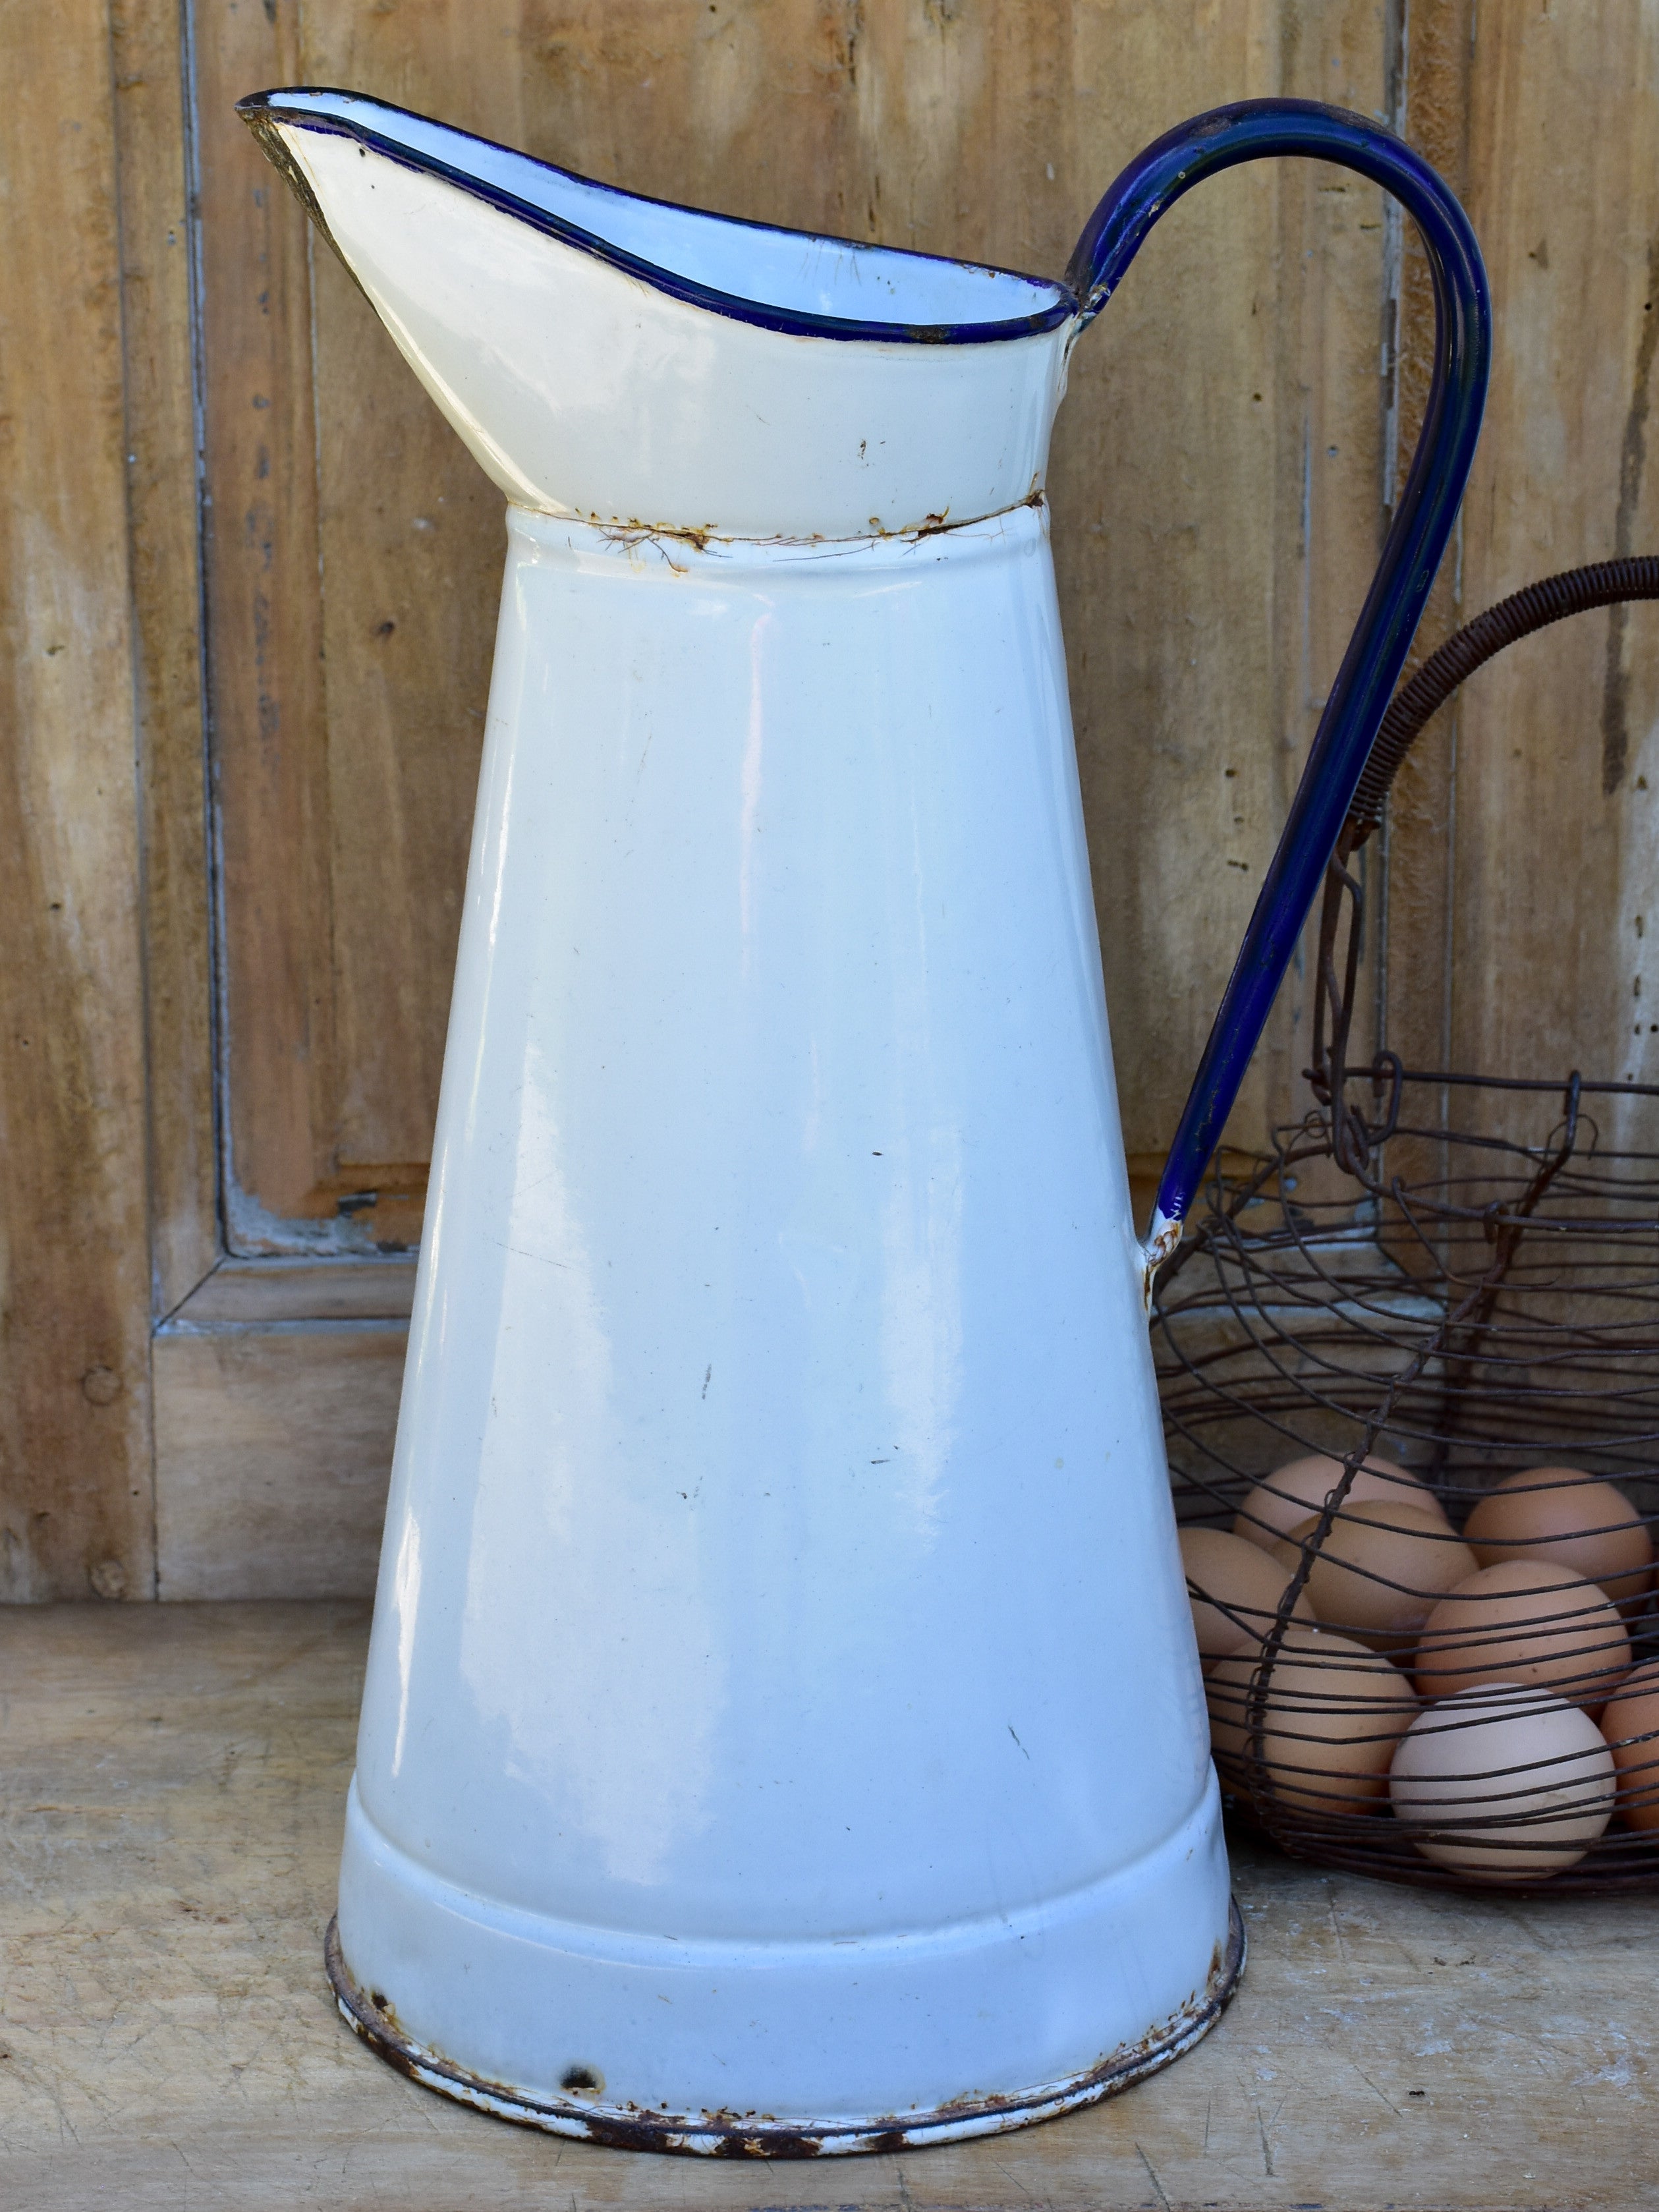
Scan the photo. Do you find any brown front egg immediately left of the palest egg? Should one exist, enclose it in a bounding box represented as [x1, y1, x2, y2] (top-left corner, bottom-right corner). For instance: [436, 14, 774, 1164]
[1206, 1628, 1418, 1814]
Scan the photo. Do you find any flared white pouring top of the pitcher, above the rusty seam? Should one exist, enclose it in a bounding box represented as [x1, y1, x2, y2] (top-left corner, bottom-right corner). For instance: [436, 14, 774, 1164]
[239, 88, 1077, 538]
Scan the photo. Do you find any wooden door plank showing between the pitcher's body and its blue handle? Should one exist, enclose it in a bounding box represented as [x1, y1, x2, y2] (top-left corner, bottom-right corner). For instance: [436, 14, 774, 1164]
[1066, 5, 1283, 1168]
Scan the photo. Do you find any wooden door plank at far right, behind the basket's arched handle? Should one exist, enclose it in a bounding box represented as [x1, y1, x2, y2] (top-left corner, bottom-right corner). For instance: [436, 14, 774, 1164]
[1451, 0, 1659, 1139]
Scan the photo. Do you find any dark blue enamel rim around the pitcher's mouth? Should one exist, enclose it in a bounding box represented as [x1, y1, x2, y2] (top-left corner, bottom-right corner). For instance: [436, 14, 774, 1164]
[237, 84, 1079, 345]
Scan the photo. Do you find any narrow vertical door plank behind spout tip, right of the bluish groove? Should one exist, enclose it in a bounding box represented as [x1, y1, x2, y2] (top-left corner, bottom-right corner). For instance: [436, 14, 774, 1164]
[192, 0, 334, 1250]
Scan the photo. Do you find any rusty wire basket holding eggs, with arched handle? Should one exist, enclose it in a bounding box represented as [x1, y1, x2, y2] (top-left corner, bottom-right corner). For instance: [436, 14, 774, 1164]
[1152, 559, 1659, 1894]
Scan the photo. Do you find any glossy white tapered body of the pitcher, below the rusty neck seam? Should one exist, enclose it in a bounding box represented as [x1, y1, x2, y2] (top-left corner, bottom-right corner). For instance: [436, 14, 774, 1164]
[341, 504, 1227, 2128]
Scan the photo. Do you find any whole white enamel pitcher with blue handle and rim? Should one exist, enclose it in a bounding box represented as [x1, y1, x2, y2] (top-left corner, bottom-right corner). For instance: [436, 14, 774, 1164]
[243, 91, 1488, 2155]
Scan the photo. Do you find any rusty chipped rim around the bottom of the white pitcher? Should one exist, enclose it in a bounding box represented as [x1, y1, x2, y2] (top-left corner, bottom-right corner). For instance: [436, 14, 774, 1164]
[323, 1898, 1245, 2159]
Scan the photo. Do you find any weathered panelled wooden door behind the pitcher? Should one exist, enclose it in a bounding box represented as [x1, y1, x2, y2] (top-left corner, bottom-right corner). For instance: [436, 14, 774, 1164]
[0, 0, 1659, 1597]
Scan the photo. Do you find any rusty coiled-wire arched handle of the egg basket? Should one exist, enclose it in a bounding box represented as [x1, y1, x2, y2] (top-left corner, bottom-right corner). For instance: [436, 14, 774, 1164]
[1307, 553, 1659, 1172]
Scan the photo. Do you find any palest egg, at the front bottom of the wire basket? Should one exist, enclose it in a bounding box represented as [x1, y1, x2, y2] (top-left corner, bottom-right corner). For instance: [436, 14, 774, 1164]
[1389, 1684, 1615, 1883]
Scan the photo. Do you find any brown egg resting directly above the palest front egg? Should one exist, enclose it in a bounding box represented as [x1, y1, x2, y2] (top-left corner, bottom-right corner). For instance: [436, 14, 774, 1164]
[1411, 1560, 1630, 1712]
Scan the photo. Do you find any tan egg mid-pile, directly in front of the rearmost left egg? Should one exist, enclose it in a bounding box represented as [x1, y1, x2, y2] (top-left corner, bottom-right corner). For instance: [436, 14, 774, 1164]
[1272, 1498, 1475, 1653]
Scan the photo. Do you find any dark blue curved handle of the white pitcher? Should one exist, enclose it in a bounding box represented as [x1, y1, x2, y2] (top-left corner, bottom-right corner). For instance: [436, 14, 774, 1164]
[1066, 99, 1491, 1290]
